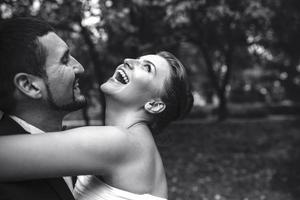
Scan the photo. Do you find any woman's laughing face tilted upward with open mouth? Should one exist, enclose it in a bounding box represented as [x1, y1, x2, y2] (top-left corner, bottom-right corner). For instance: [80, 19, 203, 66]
[101, 55, 171, 106]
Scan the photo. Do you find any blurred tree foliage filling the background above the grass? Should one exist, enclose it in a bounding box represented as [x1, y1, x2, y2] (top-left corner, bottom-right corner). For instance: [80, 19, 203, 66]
[0, 0, 300, 119]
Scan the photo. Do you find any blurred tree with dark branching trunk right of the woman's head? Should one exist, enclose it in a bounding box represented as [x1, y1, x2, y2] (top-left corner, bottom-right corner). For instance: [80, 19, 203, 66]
[167, 0, 273, 120]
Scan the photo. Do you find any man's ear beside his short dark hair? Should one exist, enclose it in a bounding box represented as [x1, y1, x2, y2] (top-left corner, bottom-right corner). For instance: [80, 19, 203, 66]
[14, 73, 42, 99]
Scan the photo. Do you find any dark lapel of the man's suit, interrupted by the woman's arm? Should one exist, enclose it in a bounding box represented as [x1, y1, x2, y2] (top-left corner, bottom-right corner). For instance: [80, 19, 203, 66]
[0, 114, 74, 200]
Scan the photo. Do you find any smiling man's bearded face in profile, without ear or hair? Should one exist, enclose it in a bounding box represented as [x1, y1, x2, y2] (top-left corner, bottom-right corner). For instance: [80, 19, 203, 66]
[39, 32, 86, 111]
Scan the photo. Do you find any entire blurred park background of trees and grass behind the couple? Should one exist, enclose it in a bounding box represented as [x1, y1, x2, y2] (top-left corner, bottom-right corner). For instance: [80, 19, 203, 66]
[0, 0, 300, 200]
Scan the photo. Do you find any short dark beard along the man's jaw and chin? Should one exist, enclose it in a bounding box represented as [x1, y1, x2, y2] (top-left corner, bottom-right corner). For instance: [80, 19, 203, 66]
[46, 84, 87, 112]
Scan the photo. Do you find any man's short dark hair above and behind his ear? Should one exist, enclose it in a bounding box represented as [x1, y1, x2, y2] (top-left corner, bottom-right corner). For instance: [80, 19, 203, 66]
[0, 17, 54, 113]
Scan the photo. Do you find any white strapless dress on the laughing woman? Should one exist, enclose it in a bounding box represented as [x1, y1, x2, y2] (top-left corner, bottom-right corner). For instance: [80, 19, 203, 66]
[73, 175, 167, 200]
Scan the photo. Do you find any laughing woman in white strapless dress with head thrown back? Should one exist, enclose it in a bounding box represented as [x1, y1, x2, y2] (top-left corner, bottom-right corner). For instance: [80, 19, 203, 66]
[0, 52, 192, 200]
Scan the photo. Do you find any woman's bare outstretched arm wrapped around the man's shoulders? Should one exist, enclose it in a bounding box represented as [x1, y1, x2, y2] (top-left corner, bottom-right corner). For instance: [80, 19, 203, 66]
[0, 126, 131, 181]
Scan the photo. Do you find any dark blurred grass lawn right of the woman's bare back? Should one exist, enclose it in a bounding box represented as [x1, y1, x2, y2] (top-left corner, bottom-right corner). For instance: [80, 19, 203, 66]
[158, 120, 300, 200]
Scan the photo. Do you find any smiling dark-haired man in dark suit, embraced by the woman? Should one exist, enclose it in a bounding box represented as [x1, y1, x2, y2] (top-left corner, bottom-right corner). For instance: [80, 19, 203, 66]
[0, 18, 86, 200]
